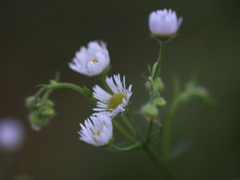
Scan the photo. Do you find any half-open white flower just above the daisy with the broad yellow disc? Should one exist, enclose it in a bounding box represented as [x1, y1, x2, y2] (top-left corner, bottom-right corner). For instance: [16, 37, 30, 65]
[68, 41, 110, 76]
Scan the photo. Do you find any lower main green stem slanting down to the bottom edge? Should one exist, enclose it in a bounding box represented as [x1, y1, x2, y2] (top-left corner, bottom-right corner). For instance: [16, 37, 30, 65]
[144, 145, 177, 180]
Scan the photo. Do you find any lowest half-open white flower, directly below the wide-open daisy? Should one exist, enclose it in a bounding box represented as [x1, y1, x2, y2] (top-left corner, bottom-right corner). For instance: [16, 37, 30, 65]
[78, 113, 113, 146]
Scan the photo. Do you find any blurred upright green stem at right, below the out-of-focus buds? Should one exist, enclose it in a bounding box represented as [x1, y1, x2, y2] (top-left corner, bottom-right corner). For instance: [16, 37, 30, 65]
[162, 96, 179, 166]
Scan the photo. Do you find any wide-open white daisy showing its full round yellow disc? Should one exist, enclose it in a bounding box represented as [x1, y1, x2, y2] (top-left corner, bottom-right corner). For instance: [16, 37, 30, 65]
[93, 74, 132, 117]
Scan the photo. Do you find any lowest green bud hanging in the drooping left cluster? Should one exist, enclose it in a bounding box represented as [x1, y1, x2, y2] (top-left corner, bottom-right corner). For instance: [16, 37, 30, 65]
[29, 111, 49, 130]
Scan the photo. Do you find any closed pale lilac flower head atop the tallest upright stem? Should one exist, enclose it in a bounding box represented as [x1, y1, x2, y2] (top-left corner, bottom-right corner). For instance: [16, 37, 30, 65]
[149, 9, 183, 36]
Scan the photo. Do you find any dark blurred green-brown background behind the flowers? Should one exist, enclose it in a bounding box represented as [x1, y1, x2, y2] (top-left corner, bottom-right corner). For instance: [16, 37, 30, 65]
[0, 0, 240, 180]
